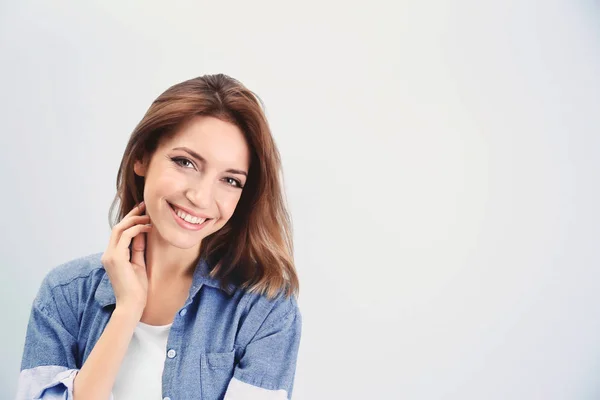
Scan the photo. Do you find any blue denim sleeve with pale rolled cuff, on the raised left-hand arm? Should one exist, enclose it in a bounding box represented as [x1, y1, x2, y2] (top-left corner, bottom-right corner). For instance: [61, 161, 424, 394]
[16, 278, 79, 400]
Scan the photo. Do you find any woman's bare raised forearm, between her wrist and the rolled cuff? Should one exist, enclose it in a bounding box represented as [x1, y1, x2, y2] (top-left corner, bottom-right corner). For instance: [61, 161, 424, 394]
[73, 307, 141, 400]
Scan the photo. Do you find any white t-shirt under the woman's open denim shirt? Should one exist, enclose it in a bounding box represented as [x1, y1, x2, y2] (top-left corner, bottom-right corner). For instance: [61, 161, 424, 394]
[112, 321, 173, 400]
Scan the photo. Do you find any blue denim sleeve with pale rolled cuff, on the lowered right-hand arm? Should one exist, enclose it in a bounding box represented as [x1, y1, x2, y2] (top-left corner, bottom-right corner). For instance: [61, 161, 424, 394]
[225, 300, 302, 400]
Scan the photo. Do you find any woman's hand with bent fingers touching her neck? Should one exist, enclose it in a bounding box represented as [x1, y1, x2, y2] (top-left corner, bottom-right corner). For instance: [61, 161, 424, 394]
[101, 202, 152, 318]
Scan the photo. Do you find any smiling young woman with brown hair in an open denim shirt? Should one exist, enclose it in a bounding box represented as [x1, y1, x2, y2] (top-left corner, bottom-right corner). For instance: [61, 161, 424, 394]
[17, 74, 302, 400]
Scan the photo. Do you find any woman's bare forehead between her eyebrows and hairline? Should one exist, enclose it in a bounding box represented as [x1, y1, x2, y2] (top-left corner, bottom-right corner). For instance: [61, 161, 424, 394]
[160, 116, 250, 170]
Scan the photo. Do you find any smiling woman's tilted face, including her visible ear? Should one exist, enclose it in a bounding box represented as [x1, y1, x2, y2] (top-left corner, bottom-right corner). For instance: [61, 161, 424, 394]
[134, 116, 250, 249]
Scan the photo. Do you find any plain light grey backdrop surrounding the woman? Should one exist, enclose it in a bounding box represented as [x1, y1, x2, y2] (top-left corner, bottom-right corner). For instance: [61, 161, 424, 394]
[0, 0, 600, 400]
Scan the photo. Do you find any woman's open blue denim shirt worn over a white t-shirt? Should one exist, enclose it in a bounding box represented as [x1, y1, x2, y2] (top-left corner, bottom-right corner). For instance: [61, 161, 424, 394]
[17, 253, 302, 400]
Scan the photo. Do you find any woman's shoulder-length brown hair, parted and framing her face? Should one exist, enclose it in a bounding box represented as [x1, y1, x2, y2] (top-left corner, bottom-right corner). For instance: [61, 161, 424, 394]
[109, 74, 299, 298]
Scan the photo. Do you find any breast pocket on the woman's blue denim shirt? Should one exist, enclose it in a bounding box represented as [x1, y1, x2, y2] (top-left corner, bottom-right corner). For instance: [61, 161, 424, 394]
[200, 350, 235, 400]
